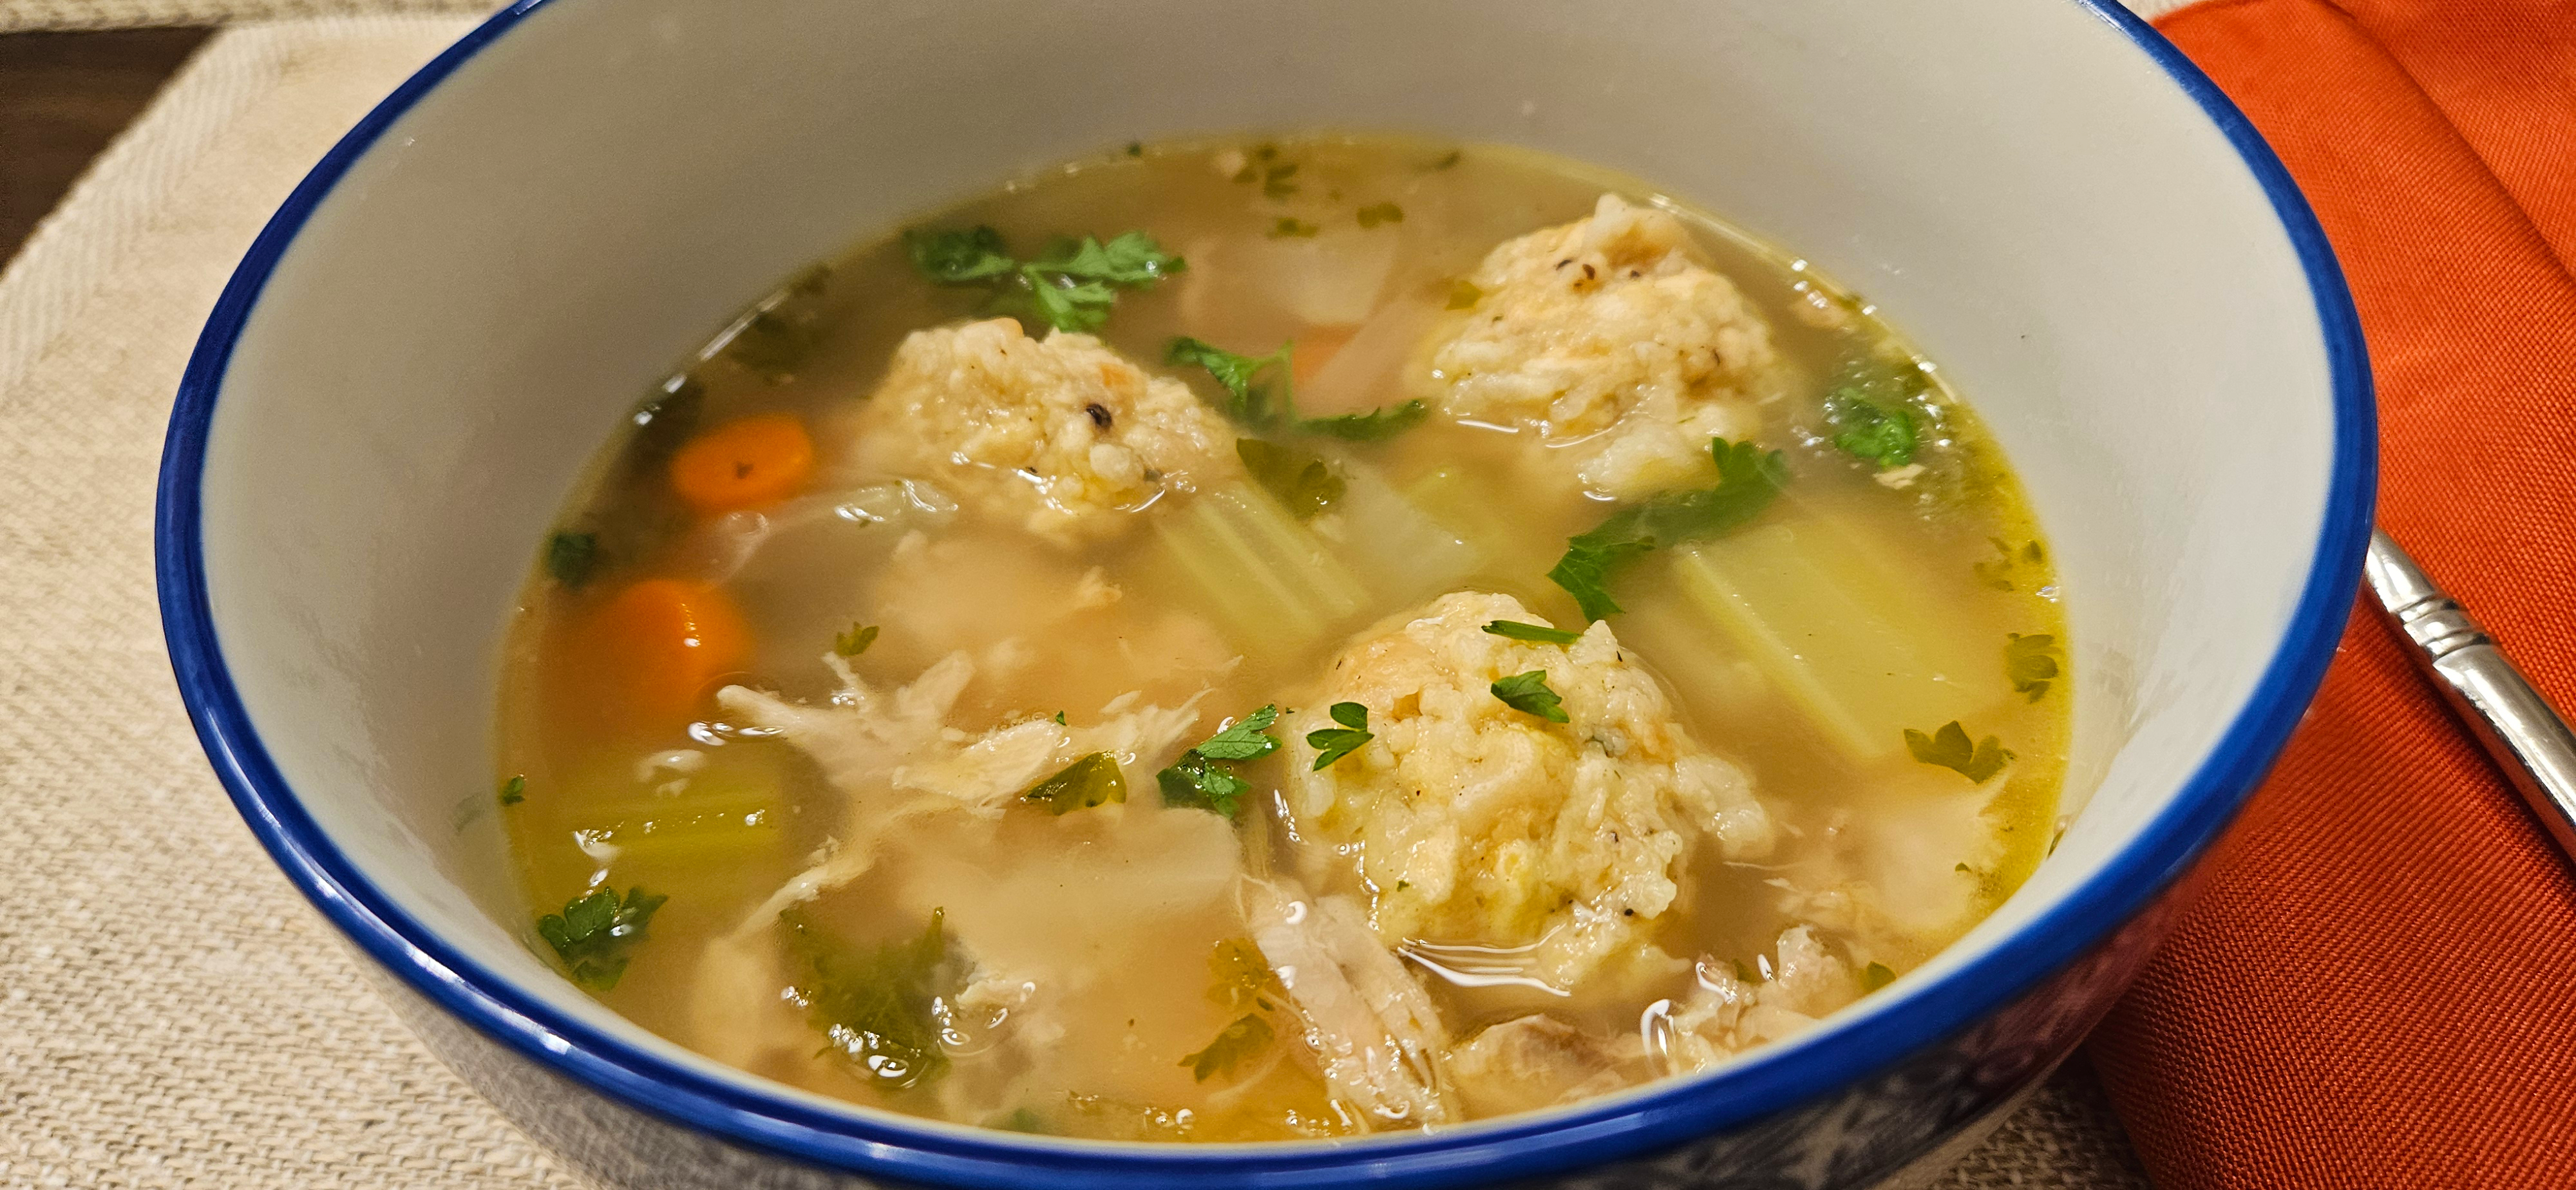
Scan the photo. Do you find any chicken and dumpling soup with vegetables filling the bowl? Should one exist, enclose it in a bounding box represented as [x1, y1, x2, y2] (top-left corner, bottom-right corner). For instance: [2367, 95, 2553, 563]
[497, 137, 2069, 1141]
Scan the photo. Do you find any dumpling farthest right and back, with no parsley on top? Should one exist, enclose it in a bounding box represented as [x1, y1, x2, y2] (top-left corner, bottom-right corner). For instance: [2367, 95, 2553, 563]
[1432, 193, 1775, 497]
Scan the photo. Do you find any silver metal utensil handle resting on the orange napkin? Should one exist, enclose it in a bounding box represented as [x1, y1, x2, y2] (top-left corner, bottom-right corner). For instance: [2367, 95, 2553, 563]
[2362, 531, 2576, 860]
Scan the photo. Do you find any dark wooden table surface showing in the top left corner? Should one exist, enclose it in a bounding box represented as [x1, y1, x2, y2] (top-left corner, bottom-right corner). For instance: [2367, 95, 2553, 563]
[0, 28, 211, 260]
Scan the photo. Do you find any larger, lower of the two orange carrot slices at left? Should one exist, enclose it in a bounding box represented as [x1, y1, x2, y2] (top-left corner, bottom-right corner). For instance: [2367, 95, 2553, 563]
[580, 580, 752, 729]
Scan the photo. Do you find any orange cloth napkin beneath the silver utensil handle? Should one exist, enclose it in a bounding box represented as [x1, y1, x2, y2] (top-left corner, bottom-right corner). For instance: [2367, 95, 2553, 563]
[2092, 0, 2576, 1190]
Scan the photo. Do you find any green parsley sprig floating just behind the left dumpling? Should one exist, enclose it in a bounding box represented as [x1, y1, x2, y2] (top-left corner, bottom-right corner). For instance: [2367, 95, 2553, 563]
[904, 227, 1188, 330]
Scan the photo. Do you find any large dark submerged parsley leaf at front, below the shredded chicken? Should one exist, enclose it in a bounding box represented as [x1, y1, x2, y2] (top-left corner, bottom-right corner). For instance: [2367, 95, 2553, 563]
[778, 909, 953, 1090]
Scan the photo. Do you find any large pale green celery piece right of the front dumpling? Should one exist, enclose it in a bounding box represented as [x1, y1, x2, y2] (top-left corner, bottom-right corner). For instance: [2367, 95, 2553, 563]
[1672, 518, 2004, 762]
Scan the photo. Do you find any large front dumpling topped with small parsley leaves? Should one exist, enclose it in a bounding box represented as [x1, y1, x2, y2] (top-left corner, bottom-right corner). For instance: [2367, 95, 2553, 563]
[1283, 592, 1772, 989]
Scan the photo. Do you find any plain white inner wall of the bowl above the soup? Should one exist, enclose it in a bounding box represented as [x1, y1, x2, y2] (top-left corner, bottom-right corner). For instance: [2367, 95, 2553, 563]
[198, 0, 2334, 1164]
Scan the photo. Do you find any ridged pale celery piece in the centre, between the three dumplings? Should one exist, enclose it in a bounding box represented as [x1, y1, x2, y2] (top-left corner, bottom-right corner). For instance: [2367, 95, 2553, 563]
[1154, 484, 1368, 654]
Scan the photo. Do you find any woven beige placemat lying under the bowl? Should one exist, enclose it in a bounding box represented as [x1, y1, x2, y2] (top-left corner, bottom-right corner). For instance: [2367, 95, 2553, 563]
[0, 18, 2146, 1190]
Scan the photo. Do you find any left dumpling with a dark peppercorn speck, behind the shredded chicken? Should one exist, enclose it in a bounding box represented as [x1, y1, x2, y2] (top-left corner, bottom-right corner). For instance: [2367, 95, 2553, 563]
[858, 319, 1242, 543]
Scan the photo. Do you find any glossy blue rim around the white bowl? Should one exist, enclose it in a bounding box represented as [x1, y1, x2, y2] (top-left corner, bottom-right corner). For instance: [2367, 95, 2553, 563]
[155, 0, 2378, 1190]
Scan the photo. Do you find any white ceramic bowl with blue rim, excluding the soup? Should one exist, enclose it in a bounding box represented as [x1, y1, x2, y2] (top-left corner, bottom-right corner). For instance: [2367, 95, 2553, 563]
[160, 0, 2372, 1190]
